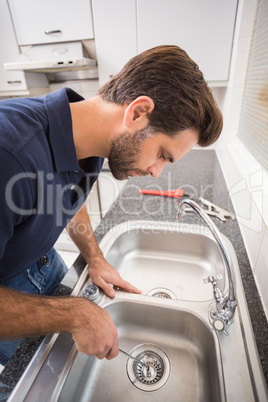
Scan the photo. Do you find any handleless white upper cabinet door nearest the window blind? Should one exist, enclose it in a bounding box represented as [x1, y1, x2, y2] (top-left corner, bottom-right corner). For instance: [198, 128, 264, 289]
[137, 0, 237, 81]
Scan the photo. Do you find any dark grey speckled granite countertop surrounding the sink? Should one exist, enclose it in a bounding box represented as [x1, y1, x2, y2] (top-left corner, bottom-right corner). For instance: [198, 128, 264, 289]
[0, 150, 268, 398]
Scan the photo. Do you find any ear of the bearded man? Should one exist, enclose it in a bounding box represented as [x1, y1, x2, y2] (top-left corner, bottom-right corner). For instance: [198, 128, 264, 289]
[124, 96, 154, 130]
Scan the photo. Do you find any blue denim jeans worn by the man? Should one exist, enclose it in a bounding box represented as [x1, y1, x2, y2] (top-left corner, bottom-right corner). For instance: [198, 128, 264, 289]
[0, 248, 68, 366]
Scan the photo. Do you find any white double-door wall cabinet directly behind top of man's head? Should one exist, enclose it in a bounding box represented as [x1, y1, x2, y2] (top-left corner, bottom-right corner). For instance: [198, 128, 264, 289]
[92, 0, 237, 85]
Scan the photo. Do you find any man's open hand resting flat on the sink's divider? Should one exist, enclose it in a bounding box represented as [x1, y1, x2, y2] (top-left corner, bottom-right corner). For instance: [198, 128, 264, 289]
[88, 253, 141, 297]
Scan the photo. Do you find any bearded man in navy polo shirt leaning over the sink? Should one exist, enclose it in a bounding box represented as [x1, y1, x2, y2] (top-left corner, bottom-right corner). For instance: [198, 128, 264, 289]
[0, 46, 222, 364]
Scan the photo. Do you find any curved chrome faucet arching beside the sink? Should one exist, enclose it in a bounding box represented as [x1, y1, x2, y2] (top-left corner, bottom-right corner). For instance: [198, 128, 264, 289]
[178, 199, 237, 329]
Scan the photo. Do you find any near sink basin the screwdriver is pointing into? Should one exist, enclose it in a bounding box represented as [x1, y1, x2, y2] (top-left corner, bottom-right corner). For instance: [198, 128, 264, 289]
[59, 301, 224, 402]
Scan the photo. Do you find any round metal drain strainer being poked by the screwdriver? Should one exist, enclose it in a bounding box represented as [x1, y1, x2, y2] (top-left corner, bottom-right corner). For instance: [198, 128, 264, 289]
[126, 344, 170, 391]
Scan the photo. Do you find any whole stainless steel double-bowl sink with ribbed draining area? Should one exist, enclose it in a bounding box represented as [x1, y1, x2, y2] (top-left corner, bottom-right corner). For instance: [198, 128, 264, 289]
[10, 221, 268, 402]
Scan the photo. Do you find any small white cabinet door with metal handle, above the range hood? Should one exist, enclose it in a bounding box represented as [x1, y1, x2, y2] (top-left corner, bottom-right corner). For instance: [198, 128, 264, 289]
[8, 0, 94, 45]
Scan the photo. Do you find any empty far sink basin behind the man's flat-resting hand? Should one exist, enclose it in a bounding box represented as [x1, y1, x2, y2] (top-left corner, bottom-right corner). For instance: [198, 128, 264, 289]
[101, 222, 227, 301]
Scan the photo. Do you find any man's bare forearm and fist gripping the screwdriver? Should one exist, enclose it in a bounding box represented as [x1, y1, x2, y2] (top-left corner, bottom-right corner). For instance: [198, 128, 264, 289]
[0, 286, 119, 360]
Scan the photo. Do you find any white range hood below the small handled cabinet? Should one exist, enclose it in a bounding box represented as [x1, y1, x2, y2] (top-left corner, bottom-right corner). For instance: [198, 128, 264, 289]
[4, 42, 98, 81]
